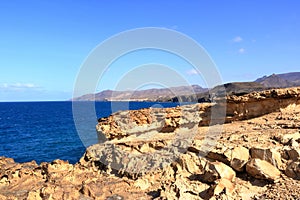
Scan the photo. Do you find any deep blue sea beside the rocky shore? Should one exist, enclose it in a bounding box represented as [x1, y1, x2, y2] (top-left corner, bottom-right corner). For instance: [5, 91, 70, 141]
[0, 101, 178, 163]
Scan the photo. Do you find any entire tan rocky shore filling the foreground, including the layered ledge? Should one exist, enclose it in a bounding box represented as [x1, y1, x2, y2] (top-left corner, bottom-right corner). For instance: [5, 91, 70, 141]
[0, 88, 300, 200]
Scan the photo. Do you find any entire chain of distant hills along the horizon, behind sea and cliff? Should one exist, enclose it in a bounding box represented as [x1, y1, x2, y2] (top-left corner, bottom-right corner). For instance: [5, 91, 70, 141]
[72, 72, 300, 102]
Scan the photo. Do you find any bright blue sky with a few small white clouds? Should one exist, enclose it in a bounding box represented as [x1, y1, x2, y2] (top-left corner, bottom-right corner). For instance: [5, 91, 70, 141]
[0, 0, 300, 101]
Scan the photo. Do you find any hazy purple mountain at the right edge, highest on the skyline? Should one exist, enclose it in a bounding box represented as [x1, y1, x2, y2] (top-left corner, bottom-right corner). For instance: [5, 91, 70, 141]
[255, 72, 300, 88]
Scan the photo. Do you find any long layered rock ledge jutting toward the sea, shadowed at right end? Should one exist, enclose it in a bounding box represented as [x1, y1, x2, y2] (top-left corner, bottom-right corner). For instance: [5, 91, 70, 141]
[96, 88, 300, 140]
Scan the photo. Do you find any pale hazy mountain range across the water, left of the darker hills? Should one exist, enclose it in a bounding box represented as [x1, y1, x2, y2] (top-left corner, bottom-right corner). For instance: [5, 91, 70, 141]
[72, 85, 208, 101]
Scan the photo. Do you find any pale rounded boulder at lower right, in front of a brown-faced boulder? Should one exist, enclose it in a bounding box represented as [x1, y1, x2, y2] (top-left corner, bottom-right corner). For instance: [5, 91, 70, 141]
[246, 158, 280, 181]
